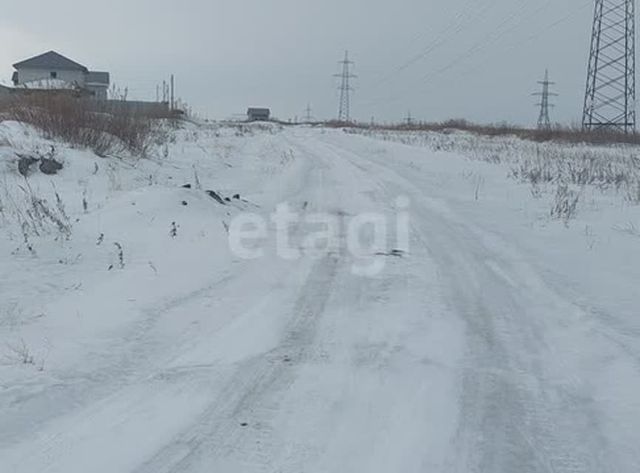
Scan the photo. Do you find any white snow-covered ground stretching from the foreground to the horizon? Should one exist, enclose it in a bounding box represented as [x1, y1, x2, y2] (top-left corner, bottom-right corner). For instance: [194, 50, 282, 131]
[0, 122, 640, 473]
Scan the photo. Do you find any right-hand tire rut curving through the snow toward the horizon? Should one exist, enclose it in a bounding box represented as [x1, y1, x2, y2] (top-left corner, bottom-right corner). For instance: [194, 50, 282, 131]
[312, 136, 610, 473]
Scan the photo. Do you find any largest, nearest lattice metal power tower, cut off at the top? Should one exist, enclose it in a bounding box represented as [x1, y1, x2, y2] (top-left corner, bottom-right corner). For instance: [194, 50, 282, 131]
[582, 0, 636, 133]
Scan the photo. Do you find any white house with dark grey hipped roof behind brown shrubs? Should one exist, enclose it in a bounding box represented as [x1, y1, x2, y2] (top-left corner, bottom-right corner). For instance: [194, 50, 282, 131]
[12, 51, 109, 100]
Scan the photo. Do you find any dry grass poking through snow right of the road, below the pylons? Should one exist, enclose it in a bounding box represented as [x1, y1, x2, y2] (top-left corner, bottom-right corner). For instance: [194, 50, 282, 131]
[346, 127, 640, 223]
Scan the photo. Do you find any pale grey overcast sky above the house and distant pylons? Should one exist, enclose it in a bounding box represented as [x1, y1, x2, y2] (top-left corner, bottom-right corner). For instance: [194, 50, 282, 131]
[0, 0, 594, 124]
